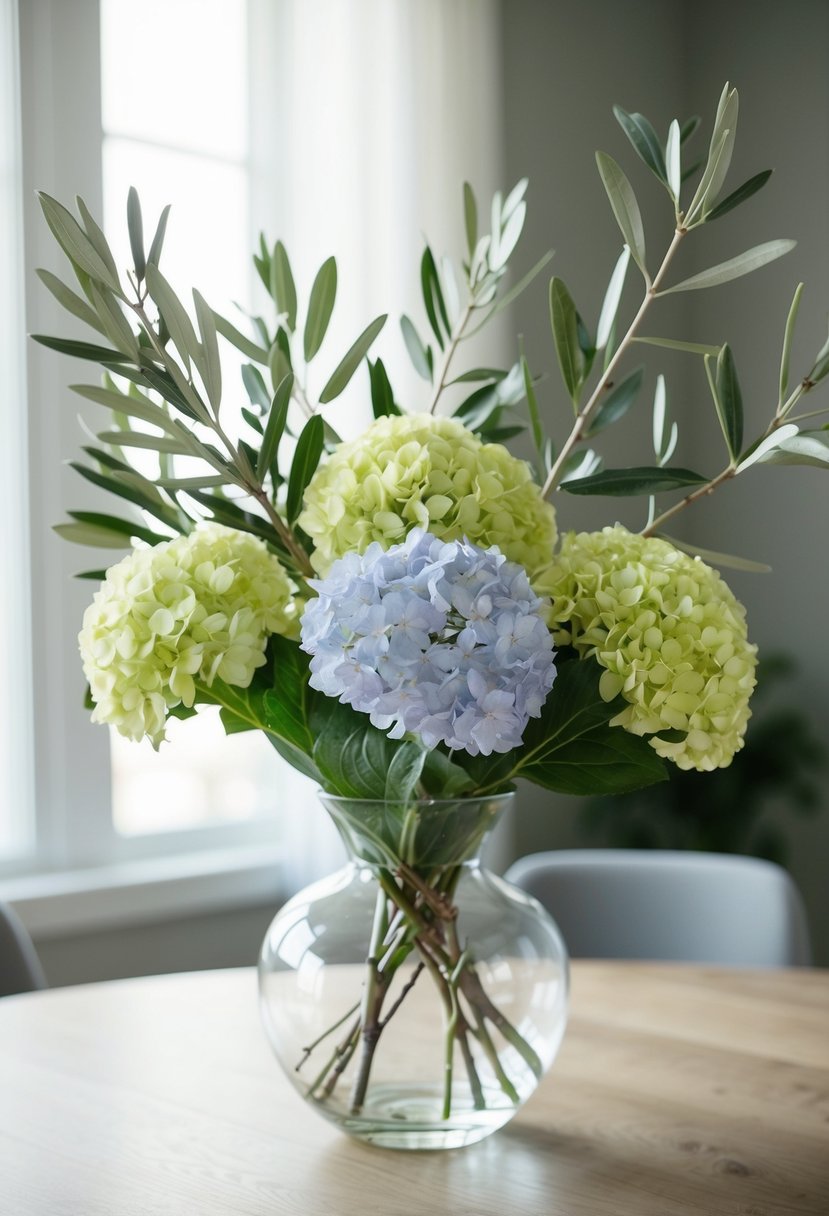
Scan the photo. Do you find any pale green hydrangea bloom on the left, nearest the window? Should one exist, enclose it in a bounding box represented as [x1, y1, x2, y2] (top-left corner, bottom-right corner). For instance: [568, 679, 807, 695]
[78, 523, 298, 747]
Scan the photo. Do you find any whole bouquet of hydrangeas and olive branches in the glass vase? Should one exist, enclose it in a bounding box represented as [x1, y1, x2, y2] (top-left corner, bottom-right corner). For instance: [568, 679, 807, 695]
[38, 85, 829, 1138]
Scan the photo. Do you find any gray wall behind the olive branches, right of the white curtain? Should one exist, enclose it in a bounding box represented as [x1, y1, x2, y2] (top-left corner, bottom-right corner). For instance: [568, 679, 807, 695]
[502, 0, 829, 964]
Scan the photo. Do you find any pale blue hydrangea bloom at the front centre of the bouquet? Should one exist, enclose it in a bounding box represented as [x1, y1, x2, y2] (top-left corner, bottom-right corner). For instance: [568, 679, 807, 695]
[301, 528, 556, 755]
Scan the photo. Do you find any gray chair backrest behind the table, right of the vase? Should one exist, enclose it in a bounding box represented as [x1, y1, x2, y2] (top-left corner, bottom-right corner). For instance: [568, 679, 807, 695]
[504, 849, 812, 967]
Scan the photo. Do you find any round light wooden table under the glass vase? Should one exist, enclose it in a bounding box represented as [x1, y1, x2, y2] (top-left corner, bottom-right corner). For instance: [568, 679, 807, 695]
[0, 963, 829, 1216]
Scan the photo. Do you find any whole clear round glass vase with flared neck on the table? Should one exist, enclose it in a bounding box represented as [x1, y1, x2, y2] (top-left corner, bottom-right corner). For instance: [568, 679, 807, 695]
[259, 794, 568, 1149]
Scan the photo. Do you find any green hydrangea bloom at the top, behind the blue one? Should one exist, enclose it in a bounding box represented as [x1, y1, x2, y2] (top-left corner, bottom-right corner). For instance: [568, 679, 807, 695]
[299, 415, 556, 578]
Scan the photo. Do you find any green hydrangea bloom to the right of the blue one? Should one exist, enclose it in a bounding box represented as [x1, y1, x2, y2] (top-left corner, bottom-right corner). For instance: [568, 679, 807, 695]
[540, 527, 757, 770]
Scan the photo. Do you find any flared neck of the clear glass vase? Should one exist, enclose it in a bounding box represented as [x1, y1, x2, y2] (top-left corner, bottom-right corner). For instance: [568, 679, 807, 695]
[320, 793, 515, 871]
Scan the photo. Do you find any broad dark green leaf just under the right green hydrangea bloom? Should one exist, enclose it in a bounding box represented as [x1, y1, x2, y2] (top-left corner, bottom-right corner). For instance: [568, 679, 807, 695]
[513, 659, 667, 795]
